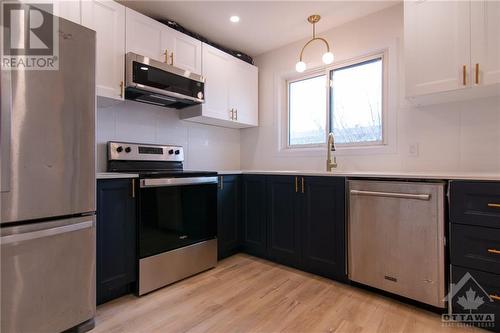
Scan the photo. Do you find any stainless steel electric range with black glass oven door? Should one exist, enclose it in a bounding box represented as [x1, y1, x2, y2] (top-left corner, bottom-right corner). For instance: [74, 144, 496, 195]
[108, 142, 218, 295]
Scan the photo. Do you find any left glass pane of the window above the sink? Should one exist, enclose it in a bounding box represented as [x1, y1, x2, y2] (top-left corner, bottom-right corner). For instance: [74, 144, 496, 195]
[288, 74, 327, 146]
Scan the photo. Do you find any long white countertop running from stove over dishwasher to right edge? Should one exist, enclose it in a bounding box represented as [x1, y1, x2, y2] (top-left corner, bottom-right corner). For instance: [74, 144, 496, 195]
[218, 170, 500, 181]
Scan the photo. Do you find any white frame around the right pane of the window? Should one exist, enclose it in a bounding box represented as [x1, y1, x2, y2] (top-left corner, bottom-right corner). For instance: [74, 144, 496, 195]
[327, 50, 388, 148]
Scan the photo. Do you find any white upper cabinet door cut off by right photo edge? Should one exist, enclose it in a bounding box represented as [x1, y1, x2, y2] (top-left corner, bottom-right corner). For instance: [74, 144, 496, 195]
[471, 1, 500, 85]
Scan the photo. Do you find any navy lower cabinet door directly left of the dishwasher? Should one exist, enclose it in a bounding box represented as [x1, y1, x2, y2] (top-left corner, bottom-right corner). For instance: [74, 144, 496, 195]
[302, 177, 346, 280]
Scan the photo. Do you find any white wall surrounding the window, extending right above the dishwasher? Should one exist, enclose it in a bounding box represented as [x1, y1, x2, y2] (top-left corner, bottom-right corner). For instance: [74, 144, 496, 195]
[241, 5, 500, 172]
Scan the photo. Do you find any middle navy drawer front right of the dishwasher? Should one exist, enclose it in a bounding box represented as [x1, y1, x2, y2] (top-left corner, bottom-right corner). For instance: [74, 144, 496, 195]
[450, 224, 500, 274]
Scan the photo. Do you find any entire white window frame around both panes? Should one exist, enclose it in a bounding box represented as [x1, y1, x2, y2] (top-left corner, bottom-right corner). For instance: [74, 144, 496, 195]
[279, 48, 389, 153]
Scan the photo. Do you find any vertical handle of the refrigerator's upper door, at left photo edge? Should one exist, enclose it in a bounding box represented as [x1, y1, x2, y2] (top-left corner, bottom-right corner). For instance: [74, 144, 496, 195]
[0, 69, 12, 192]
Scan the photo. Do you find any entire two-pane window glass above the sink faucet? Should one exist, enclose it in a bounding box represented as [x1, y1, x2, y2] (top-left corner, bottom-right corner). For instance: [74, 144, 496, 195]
[287, 54, 385, 148]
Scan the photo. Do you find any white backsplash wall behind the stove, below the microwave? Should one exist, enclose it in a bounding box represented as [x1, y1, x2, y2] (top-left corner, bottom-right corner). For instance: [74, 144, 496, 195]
[97, 101, 240, 172]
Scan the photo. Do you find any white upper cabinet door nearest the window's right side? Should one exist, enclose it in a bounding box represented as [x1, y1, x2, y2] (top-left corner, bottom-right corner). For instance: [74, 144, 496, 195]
[404, 1, 472, 97]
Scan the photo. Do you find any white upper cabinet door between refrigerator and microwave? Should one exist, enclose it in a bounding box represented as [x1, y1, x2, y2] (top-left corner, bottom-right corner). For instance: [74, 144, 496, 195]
[82, 0, 125, 100]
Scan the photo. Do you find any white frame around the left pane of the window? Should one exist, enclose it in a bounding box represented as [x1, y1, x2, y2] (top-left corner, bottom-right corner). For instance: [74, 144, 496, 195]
[285, 70, 330, 149]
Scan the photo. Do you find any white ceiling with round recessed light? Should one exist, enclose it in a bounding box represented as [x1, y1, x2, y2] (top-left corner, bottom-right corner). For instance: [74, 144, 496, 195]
[119, 0, 401, 56]
